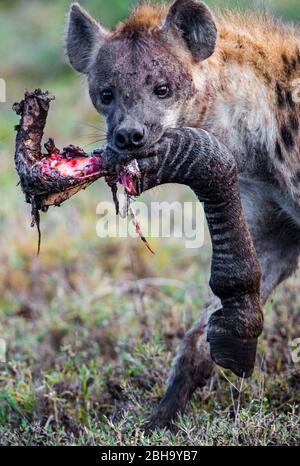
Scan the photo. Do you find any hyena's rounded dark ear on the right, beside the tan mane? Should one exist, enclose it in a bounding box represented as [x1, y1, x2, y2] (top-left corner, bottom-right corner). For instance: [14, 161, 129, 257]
[163, 0, 217, 61]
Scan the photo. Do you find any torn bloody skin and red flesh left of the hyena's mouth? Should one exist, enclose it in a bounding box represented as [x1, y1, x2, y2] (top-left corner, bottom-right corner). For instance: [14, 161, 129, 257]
[13, 89, 151, 254]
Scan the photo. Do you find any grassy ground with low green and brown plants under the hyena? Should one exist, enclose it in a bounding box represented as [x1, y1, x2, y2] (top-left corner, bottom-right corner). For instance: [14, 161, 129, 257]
[0, 180, 300, 445]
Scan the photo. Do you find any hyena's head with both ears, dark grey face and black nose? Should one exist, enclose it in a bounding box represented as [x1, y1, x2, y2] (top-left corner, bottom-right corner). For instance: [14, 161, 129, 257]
[66, 0, 217, 153]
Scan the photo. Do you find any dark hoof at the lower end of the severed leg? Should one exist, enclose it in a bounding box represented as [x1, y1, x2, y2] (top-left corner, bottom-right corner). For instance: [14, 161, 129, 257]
[208, 335, 257, 378]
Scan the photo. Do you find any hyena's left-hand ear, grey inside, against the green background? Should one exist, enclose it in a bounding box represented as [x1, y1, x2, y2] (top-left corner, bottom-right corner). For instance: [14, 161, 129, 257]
[66, 3, 108, 74]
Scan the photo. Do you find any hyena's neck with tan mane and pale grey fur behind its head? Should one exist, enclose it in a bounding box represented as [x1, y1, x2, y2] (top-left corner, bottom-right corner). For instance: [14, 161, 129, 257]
[185, 15, 300, 186]
